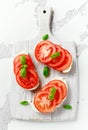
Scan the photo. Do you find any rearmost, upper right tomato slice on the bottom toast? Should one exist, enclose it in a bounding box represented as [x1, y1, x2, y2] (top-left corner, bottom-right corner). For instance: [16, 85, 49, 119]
[48, 80, 68, 99]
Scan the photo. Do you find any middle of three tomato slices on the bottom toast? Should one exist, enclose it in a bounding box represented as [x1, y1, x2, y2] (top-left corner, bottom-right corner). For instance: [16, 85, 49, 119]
[42, 84, 62, 105]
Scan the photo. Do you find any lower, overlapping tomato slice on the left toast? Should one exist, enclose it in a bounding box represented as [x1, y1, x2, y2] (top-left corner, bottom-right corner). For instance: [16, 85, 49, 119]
[16, 69, 39, 89]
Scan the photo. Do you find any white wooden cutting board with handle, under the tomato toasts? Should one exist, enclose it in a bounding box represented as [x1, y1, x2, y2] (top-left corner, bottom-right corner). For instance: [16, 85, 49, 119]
[10, 9, 78, 121]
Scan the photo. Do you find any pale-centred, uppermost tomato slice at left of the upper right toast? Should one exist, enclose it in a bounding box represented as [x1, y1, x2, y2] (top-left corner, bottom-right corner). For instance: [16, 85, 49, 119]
[35, 40, 56, 63]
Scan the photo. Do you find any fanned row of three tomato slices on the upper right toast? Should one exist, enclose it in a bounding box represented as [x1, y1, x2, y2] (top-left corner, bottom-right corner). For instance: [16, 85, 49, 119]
[35, 40, 72, 72]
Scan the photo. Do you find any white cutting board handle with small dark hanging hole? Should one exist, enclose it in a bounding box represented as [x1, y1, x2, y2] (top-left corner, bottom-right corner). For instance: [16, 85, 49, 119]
[38, 8, 52, 35]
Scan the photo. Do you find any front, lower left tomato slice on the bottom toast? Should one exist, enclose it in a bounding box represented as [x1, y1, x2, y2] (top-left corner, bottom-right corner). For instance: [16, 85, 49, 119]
[34, 91, 56, 113]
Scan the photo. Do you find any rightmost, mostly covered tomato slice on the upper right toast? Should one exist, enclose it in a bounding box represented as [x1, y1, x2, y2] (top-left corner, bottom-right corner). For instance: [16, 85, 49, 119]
[54, 49, 72, 71]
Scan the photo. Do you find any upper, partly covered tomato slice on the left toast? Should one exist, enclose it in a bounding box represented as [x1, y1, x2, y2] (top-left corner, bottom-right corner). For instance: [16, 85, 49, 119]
[13, 54, 34, 74]
